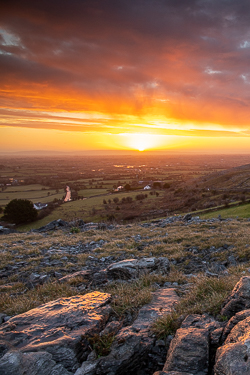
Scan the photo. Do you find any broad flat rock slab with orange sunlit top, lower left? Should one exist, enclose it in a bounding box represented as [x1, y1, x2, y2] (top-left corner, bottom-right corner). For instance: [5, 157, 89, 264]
[0, 292, 111, 371]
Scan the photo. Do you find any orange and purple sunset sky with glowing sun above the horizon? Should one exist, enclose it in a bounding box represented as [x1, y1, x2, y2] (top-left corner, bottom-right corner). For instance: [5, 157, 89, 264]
[0, 0, 250, 153]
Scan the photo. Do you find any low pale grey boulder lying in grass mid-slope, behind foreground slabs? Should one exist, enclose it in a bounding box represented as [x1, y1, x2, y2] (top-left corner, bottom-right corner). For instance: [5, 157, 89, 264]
[107, 257, 170, 280]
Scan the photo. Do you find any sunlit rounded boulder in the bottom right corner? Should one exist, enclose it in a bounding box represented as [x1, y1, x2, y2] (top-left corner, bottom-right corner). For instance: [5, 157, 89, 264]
[214, 317, 250, 375]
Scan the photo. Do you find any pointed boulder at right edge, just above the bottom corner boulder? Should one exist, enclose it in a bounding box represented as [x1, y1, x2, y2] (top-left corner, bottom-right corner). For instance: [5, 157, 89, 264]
[221, 276, 250, 318]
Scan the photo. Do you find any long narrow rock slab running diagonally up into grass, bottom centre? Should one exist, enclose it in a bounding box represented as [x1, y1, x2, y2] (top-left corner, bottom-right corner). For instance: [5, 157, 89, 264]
[75, 288, 179, 375]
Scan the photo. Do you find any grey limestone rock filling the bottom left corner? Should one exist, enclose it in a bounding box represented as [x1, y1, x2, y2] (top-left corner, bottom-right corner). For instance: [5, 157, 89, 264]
[0, 351, 73, 375]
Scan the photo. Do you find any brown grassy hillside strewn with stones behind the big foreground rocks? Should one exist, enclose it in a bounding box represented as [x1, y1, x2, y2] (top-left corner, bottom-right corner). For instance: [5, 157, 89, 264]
[0, 219, 250, 336]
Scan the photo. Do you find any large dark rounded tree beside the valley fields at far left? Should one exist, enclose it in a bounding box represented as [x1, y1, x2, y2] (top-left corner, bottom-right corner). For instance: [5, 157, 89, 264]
[4, 199, 37, 224]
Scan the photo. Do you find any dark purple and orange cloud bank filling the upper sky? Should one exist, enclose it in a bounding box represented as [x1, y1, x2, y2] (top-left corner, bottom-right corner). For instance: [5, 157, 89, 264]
[0, 0, 250, 126]
